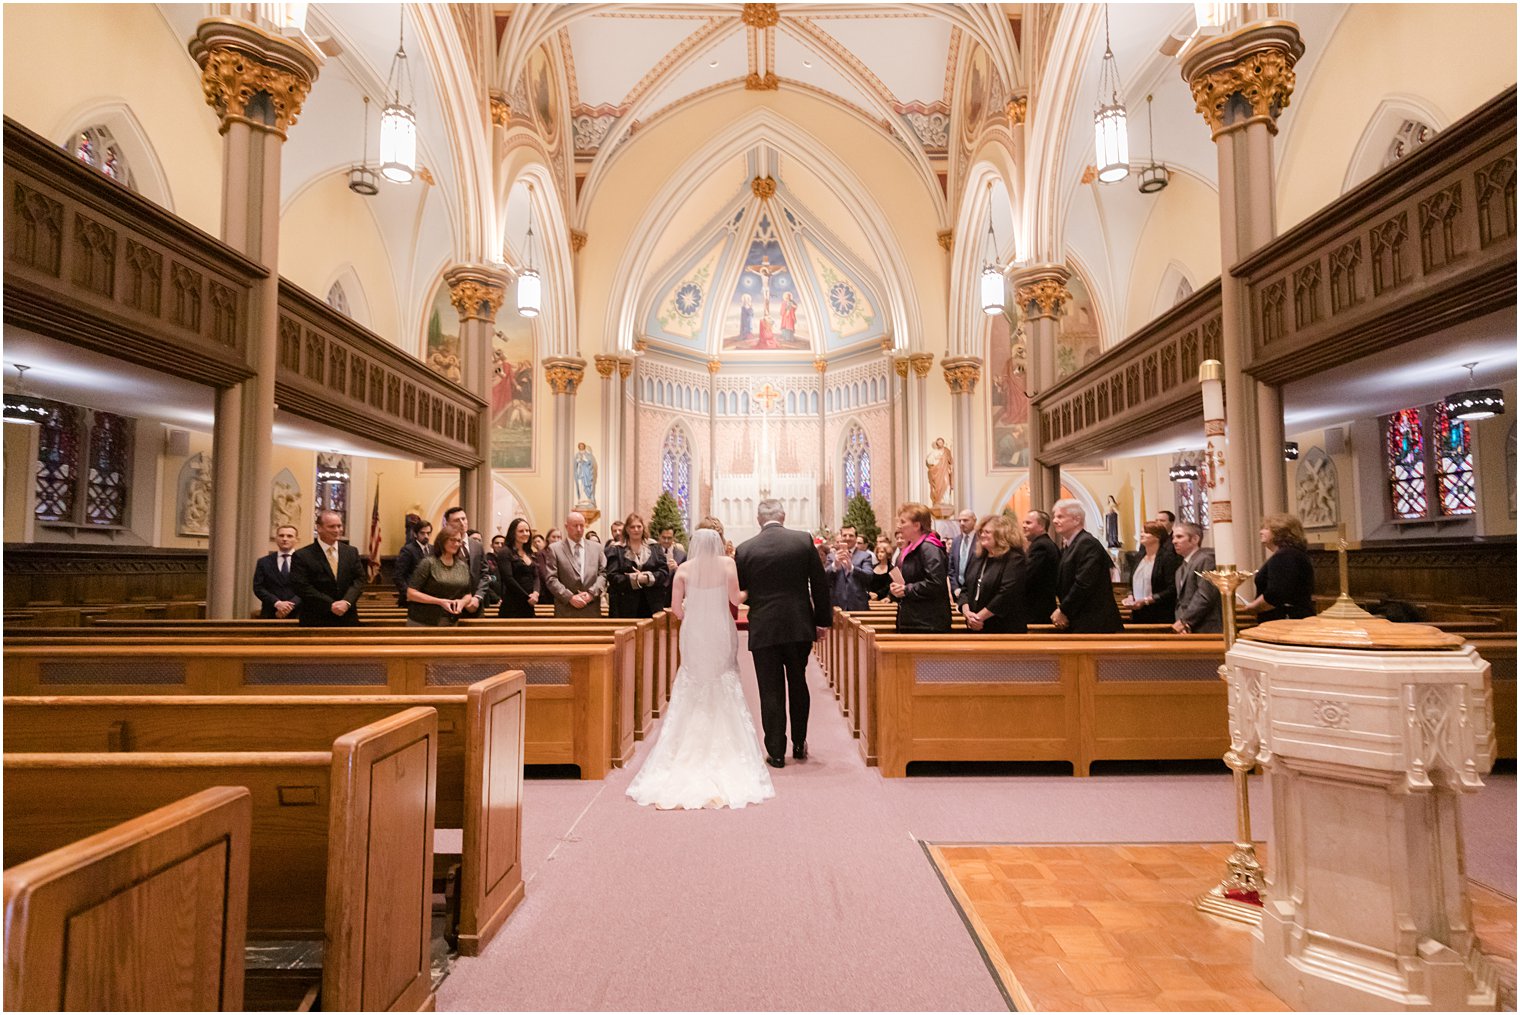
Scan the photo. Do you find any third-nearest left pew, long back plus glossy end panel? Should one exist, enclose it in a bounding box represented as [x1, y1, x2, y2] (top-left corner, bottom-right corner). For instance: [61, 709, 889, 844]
[3, 670, 526, 956]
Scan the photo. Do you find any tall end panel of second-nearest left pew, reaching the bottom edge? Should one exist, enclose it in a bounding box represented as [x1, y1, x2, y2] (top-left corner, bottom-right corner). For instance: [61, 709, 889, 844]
[322, 707, 438, 1012]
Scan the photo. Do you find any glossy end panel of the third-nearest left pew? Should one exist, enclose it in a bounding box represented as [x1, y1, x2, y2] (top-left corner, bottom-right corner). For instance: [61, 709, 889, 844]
[459, 670, 527, 956]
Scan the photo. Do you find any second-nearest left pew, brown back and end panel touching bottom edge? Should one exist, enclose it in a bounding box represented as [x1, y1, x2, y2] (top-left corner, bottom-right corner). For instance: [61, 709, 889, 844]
[5, 708, 438, 1010]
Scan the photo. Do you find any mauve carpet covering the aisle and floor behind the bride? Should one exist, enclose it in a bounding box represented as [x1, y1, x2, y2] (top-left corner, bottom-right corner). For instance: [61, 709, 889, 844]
[438, 638, 1515, 1010]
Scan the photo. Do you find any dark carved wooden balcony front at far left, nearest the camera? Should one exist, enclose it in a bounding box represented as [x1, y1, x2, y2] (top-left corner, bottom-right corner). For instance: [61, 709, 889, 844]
[5, 119, 269, 386]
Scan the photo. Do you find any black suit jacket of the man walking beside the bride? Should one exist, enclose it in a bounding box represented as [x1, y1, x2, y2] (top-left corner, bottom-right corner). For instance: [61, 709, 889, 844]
[734, 526, 834, 652]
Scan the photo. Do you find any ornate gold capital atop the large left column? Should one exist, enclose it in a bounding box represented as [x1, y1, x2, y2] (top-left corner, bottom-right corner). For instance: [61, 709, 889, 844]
[190, 18, 322, 138]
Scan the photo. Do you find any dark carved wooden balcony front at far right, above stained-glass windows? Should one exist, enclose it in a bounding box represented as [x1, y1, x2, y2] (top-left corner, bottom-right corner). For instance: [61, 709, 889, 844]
[1231, 88, 1515, 384]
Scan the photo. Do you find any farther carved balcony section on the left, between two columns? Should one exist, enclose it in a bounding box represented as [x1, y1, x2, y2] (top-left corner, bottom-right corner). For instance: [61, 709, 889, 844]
[275, 278, 485, 468]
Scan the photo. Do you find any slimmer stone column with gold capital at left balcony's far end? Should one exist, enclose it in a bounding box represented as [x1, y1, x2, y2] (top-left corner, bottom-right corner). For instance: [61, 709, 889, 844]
[444, 264, 506, 531]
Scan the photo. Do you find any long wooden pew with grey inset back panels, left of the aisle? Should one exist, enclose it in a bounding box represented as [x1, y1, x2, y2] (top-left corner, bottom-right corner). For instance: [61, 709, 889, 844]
[5, 641, 634, 779]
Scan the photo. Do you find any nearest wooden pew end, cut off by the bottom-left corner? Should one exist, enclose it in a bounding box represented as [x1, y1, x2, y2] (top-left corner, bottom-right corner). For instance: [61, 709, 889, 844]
[5, 786, 252, 1012]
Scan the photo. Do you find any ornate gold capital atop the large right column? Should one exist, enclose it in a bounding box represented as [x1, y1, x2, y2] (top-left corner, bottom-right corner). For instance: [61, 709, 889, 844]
[1180, 20, 1304, 138]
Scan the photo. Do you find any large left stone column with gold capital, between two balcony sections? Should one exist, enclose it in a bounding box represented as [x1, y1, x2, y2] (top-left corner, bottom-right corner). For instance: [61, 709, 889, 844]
[190, 18, 322, 620]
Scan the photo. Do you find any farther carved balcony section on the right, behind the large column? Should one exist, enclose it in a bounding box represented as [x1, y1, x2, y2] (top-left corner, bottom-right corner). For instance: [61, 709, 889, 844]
[1034, 278, 1221, 462]
